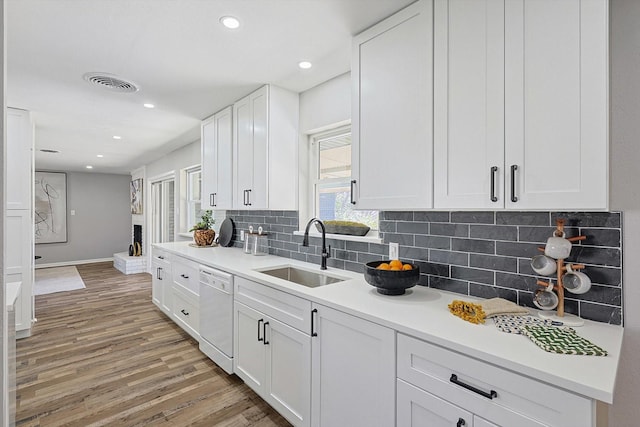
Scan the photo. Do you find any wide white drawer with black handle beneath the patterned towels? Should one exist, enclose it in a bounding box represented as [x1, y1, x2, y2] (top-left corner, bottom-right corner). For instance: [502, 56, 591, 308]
[397, 334, 595, 427]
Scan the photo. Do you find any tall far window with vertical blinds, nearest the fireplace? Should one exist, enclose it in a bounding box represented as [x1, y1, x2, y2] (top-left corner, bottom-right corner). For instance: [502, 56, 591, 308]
[151, 177, 175, 243]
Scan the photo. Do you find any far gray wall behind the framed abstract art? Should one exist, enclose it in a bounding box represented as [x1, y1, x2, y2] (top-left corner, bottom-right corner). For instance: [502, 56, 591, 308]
[35, 172, 132, 265]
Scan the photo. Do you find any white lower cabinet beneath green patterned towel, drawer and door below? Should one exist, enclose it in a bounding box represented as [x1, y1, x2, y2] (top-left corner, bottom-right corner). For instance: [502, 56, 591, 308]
[397, 334, 595, 427]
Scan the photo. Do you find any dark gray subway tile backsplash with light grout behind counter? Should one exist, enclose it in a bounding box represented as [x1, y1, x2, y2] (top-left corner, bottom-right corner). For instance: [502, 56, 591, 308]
[227, 211, 623, 325]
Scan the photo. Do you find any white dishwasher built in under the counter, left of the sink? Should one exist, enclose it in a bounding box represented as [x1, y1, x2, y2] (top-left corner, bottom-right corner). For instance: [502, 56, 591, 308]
[199, 265, 233, 374]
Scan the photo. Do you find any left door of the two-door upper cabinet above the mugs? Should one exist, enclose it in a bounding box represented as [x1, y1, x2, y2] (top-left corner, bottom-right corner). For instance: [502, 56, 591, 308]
[433, 0, 505, 209]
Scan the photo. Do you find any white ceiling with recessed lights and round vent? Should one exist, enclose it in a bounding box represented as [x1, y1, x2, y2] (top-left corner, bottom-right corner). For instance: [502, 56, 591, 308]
[6, 0, 413, 173]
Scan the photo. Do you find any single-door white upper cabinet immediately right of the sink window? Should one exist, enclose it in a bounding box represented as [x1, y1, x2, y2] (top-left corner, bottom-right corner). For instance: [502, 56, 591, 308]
[351, 0, 433, 209]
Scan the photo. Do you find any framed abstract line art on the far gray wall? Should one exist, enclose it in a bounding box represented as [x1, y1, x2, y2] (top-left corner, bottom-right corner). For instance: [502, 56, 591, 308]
[33, 171, 67, 244]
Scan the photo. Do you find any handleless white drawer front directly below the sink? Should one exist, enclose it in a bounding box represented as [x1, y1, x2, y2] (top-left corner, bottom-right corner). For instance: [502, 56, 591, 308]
[234, 277, 311, 334]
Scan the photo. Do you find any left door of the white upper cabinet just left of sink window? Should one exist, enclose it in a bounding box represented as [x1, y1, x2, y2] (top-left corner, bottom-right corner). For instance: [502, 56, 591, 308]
[233, 96, 253, 209]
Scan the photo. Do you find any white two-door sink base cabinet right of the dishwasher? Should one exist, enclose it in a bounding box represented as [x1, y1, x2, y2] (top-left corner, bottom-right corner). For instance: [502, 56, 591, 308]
[233, 278, 311, 426]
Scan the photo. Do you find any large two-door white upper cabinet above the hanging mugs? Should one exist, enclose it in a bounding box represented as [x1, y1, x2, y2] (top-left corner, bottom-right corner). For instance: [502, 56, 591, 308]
[434, 0, 608, 210]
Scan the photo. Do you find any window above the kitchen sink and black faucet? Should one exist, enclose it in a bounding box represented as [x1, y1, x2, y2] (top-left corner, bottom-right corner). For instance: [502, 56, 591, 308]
[311, 127, 378, 230]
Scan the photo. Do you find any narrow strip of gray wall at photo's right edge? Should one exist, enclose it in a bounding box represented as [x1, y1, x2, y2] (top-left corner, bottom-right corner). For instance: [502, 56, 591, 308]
[609, 0, 640, 427]
